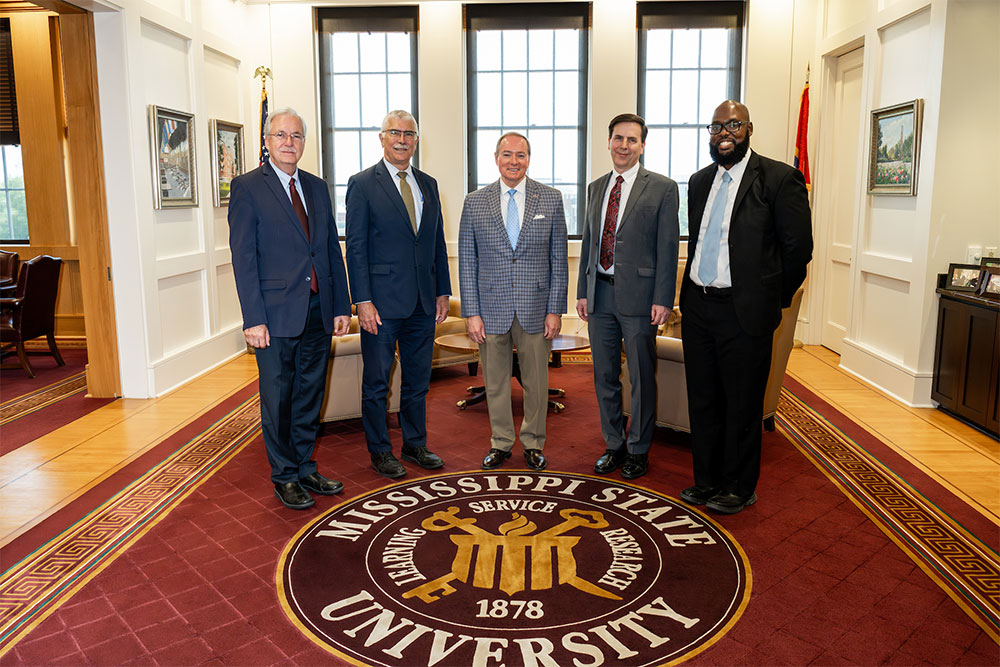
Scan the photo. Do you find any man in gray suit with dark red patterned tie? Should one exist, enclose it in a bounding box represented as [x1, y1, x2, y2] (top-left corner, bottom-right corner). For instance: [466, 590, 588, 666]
[576, 114, 678, 479]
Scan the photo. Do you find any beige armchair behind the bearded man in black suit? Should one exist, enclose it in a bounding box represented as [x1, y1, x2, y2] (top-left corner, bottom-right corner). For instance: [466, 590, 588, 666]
[622, 287, 803, 432]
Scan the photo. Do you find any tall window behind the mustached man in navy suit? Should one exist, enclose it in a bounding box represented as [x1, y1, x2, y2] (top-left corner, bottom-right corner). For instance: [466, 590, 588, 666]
[317, 7, 417, 236]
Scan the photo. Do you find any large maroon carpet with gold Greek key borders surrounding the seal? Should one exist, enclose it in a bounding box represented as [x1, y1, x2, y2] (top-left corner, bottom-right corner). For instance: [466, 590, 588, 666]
[0, 364, 1000, 665]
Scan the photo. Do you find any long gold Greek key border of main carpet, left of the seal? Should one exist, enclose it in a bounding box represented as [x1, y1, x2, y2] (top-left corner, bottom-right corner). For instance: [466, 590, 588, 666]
[0, 394, 260, 655]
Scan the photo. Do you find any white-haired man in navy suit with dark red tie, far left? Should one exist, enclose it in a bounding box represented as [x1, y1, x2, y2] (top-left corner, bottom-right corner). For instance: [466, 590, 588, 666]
[229, 109, 350, 509]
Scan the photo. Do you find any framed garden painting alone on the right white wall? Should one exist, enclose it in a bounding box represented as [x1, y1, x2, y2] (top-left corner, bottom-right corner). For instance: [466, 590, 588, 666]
[868, 99, 924, 195]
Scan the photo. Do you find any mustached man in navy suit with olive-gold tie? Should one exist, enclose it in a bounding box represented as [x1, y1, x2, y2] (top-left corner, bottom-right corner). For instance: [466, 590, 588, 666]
[347, 111, 451, 478]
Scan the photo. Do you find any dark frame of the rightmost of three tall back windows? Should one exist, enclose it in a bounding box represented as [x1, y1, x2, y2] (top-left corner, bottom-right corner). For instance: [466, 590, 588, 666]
[636, 0, 747, 241]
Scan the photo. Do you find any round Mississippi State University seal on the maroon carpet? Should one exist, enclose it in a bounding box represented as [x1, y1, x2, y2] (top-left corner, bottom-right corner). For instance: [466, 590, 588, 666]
[277, 471, 750, 667]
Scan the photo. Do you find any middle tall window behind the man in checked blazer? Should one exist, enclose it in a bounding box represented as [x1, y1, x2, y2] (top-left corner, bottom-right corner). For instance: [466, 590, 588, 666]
[465, 3, 590, 238]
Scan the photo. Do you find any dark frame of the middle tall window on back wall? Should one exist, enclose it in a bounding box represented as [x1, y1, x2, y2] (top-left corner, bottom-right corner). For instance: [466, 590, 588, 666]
[462, 2, 592, 239]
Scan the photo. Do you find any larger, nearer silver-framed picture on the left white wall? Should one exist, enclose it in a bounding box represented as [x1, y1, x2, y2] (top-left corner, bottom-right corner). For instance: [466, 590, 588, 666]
[149, 104, 198, 209]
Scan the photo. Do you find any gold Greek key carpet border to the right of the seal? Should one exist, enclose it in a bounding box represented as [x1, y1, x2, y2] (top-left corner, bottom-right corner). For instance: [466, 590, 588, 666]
[777, 388, 1000, 641]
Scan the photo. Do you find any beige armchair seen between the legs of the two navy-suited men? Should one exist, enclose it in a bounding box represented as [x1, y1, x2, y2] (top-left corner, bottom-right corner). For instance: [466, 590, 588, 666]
[320, 316, 400, 422]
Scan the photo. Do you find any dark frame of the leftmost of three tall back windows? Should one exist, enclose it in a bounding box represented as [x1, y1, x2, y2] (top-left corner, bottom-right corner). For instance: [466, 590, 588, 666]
[315, 5, 420, 240]
